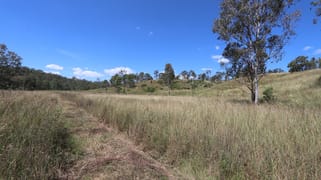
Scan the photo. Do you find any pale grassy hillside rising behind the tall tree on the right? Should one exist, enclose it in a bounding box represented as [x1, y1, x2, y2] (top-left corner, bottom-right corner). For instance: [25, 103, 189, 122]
[202, 69, 321, 108]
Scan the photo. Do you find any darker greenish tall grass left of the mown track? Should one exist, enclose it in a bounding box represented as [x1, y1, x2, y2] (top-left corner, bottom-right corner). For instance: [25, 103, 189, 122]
[0, 91, 74, 179]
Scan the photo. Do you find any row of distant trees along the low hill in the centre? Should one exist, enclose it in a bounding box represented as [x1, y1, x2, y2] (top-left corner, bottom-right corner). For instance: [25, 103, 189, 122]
[108, 63, 290, 94]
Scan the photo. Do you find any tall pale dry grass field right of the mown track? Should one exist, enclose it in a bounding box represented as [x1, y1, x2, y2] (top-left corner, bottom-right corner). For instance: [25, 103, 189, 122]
[65, 94, 321, 179]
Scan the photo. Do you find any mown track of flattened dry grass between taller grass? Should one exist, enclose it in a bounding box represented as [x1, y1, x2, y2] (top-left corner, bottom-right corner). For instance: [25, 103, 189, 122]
[60, 95, 185, 179]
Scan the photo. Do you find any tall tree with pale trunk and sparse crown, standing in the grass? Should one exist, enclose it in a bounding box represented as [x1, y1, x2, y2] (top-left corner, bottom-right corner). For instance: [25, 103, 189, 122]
[213, 0, 300, 104]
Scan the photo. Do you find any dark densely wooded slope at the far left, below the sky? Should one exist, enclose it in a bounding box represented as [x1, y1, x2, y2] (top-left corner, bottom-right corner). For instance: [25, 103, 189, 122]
[0, 44, 107, 90]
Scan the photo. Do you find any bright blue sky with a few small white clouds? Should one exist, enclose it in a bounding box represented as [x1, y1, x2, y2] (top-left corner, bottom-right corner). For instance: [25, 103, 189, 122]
[0, 0, 321, 80]
